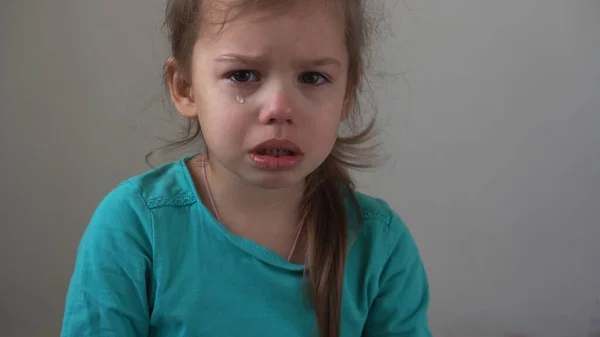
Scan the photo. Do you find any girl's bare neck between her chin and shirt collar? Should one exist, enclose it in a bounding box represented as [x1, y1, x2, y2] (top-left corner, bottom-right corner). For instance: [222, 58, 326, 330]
[191, 159, 304, 233]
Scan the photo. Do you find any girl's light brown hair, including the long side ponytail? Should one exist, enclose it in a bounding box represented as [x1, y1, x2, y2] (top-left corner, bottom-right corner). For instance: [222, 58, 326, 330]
[164, 0, 382, 337]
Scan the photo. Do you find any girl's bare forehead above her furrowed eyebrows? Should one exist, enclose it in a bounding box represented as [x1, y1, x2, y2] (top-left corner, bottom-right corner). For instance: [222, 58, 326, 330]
[198, 0, 346, 56]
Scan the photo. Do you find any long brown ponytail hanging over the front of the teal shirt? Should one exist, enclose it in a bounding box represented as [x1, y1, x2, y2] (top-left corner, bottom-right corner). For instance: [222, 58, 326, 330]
[302, 155, 360, 337]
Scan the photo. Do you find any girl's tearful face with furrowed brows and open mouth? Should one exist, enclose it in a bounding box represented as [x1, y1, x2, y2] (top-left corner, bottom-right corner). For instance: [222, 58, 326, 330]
[178, 1, 348, 188]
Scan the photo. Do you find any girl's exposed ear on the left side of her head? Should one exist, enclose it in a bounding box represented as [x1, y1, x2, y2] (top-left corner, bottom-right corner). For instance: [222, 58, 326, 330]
[164, 56, 198, 119]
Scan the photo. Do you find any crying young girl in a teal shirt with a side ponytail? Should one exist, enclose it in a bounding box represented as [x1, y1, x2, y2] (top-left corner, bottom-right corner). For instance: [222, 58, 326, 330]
[62, 0, 430, 337]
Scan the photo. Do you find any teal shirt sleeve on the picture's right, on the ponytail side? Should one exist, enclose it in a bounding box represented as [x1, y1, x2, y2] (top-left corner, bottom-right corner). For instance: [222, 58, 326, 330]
[364, 212, 431, 337]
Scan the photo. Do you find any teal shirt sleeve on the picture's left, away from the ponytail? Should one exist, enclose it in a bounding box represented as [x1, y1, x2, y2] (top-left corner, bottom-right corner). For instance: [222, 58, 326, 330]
[61, 183, 152, 337]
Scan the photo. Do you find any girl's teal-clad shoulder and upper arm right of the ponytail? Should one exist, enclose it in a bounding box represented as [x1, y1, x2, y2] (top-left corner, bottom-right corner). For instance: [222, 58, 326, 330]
[346, 192, 431, 336]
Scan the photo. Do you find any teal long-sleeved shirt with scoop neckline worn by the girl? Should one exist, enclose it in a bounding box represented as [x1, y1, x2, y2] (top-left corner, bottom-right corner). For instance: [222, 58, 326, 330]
[61, 158, 431, 337]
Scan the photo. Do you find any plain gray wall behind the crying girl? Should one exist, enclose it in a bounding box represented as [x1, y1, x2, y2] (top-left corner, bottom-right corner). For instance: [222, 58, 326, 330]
[0, 0, 600, 337]
